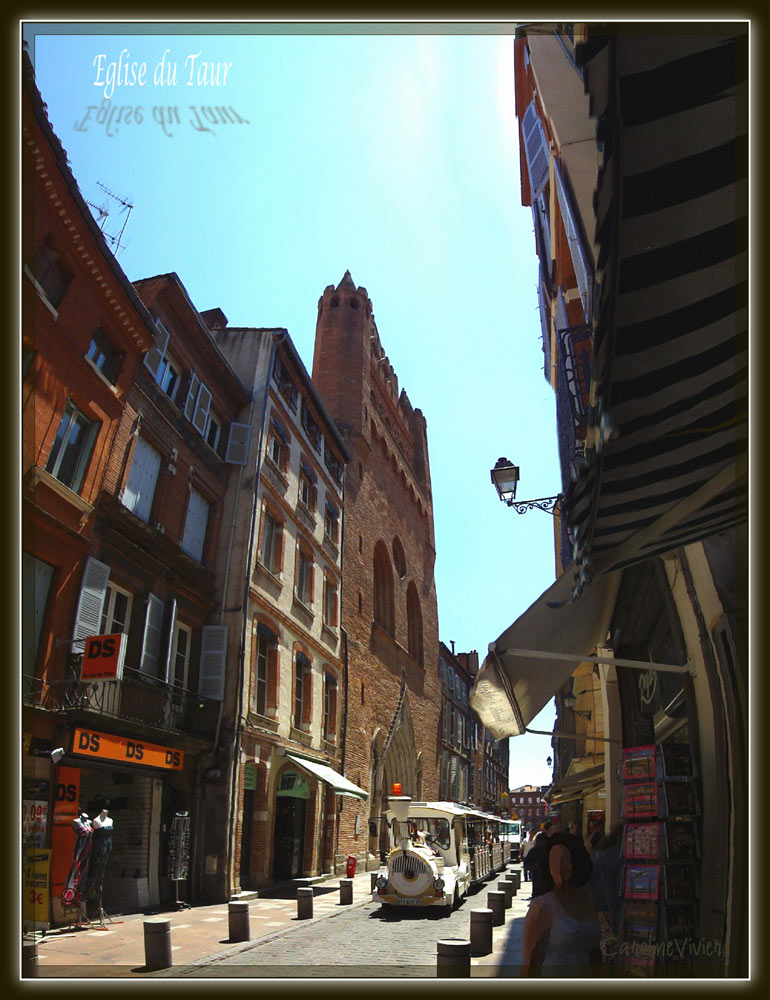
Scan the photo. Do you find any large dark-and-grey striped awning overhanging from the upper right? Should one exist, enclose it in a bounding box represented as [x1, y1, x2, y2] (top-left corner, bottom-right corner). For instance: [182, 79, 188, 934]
[564, 29, 748, 592]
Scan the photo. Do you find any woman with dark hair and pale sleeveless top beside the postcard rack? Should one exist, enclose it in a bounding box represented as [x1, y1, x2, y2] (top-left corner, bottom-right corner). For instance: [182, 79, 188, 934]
[521, 833, 602, 978]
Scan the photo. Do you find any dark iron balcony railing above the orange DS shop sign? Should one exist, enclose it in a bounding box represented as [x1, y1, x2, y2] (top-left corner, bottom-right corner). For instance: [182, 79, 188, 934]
[30, 667, 219, 739]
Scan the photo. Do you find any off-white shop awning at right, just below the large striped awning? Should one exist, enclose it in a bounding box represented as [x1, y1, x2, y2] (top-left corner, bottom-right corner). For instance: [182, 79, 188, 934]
[470, 567, 620, 740]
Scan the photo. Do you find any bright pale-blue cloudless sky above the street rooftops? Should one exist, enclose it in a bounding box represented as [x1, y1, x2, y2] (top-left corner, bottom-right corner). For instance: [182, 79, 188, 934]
[24, 22, 560, 787]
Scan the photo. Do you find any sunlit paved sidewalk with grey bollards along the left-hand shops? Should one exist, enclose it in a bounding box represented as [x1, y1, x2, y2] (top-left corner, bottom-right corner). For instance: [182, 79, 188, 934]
[29, 872, 372, 979]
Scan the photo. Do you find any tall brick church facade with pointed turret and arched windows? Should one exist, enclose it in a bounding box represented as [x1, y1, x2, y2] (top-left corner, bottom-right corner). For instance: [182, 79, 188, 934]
[313, 271, 441, 857]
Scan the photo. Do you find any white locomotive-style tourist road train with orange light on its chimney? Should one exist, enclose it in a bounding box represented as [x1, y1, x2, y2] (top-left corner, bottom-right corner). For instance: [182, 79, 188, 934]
[372, 796, 508, 914]
